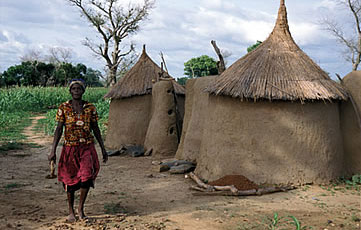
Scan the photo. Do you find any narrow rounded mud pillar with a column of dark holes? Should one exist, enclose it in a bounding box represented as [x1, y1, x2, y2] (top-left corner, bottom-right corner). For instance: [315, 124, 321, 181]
[144, 81, 178, 158]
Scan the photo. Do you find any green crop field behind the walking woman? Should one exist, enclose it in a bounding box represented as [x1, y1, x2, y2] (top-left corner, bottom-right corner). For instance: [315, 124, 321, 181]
[0, 87, 109, 145]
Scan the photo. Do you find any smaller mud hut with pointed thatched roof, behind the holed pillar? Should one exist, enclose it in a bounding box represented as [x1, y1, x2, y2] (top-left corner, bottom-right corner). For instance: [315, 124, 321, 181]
[105, 46, 184, 150]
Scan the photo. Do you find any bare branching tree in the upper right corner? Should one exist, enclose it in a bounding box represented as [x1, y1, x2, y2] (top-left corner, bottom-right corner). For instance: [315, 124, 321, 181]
[321, 0, 361, 70]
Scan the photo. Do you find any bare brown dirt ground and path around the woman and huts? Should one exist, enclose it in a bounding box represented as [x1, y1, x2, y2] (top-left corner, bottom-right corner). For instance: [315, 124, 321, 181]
[0, 118, 361, 230]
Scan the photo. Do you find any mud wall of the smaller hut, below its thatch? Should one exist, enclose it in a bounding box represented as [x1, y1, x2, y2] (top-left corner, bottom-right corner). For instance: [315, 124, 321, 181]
[105, 95, 152, 150]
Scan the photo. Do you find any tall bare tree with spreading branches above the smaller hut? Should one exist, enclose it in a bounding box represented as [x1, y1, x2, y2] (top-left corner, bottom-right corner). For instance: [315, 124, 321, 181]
[66, 0, 153, 85]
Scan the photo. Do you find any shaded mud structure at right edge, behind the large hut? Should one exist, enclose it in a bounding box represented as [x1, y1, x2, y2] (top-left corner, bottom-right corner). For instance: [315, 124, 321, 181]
[341, 71, 361, 176]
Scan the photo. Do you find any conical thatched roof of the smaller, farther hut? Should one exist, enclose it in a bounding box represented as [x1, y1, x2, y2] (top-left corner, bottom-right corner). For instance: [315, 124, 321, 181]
[104, 46, 185, 99]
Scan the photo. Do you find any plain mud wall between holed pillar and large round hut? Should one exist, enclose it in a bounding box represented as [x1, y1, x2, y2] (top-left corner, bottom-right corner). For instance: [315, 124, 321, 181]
[176, 76, 216, 162]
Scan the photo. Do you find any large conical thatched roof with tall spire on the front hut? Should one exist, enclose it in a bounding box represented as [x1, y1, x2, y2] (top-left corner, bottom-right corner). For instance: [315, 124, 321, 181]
[206, 0, 348, 101]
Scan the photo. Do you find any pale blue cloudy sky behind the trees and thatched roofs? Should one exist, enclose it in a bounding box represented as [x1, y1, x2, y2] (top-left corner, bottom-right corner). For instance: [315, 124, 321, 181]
[0, 0, 352, 79]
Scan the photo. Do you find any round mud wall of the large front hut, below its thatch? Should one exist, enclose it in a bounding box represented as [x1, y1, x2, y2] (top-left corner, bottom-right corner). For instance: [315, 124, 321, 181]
[196, 96, 343, 184]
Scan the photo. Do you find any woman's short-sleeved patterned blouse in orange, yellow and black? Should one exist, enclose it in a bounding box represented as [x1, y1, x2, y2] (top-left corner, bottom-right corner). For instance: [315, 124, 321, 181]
[55, 100, 98, 146]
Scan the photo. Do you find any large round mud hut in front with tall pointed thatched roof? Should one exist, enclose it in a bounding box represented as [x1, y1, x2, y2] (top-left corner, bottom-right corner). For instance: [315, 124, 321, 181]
[190, 0, 348, 184]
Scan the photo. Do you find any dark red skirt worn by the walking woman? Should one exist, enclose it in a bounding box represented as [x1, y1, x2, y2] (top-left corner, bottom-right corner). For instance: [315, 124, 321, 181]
[58, 143, 100, 189]
